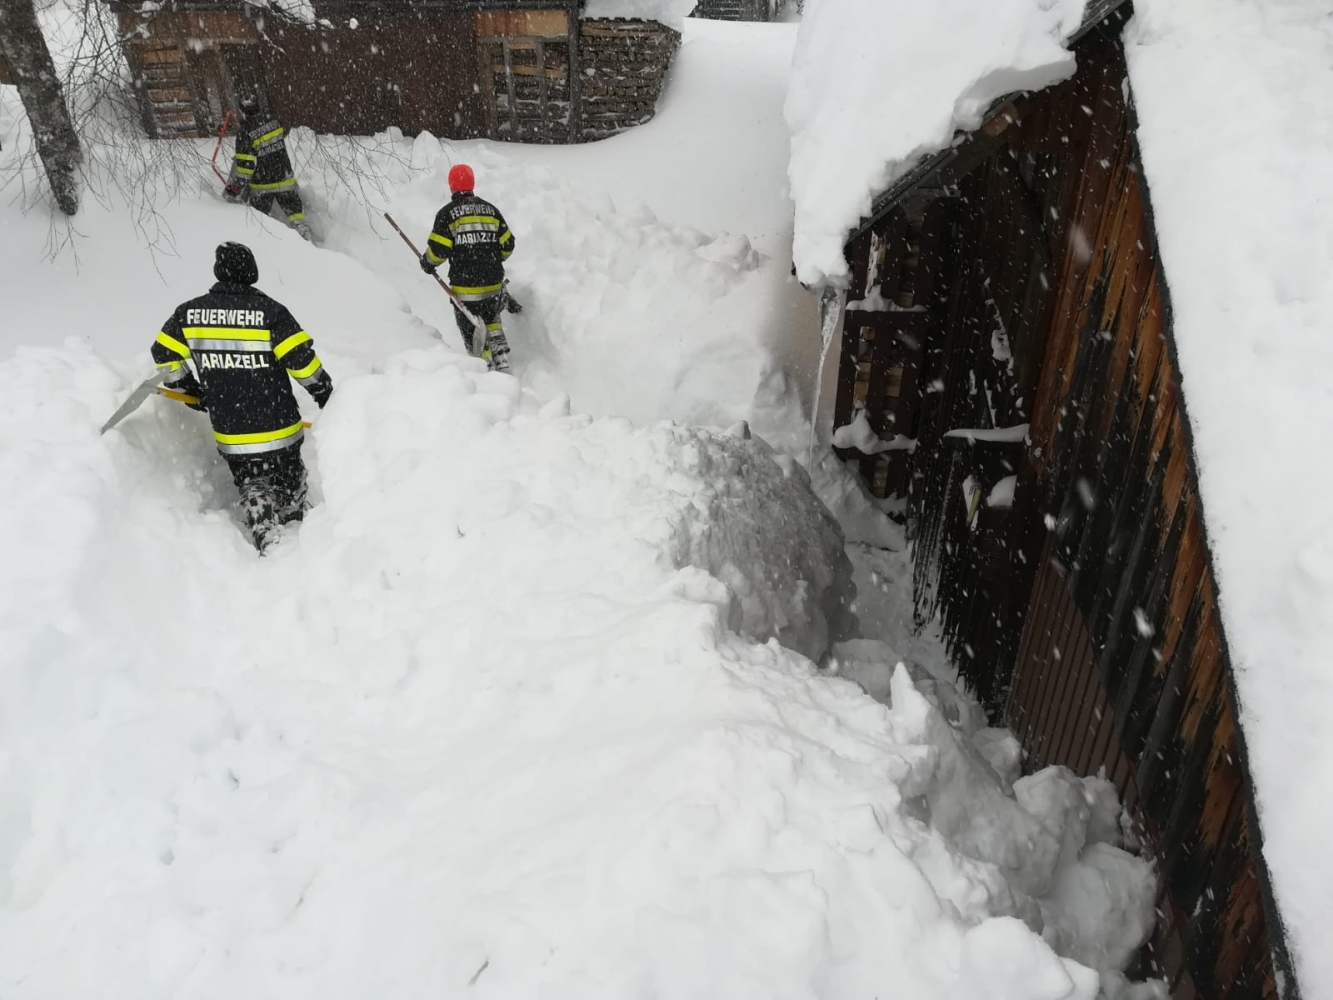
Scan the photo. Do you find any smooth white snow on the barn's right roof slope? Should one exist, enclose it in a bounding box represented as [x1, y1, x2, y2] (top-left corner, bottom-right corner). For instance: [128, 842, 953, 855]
[1126, 0, 1333, 997]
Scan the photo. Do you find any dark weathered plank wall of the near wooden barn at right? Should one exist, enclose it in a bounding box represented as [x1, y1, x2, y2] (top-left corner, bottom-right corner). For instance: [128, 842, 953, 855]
[834, 0, 1298, 1000]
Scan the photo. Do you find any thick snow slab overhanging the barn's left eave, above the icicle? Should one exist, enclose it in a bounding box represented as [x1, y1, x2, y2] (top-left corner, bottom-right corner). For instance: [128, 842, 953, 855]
[786, 0, 1084, 285]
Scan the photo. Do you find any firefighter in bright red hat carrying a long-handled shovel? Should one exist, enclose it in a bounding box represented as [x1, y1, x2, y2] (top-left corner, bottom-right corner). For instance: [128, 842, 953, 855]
[421, 163, 513, 372]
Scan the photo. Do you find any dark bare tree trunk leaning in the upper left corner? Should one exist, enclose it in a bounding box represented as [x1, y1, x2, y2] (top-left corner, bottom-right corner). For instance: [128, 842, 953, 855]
[0, 0, 81, 215]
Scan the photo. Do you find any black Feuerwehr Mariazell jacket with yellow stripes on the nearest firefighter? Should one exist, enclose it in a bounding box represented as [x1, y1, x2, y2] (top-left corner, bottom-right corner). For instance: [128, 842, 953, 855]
[152, 281, 333, 455]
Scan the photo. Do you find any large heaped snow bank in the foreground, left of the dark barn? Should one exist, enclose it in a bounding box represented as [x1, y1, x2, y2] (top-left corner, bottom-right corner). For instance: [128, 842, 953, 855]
[0, 348, 1152, 1000]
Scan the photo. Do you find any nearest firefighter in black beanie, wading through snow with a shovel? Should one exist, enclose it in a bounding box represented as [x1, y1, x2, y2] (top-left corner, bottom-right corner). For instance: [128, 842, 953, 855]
[152, 243, 333, 552]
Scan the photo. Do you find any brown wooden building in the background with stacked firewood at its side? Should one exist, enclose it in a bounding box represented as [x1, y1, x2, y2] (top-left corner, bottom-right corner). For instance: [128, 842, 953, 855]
[111, 0, 680, 143]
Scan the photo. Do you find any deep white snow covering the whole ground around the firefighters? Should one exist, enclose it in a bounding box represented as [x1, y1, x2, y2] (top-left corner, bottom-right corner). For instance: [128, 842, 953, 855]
[0, 15, 1153, 1000]
